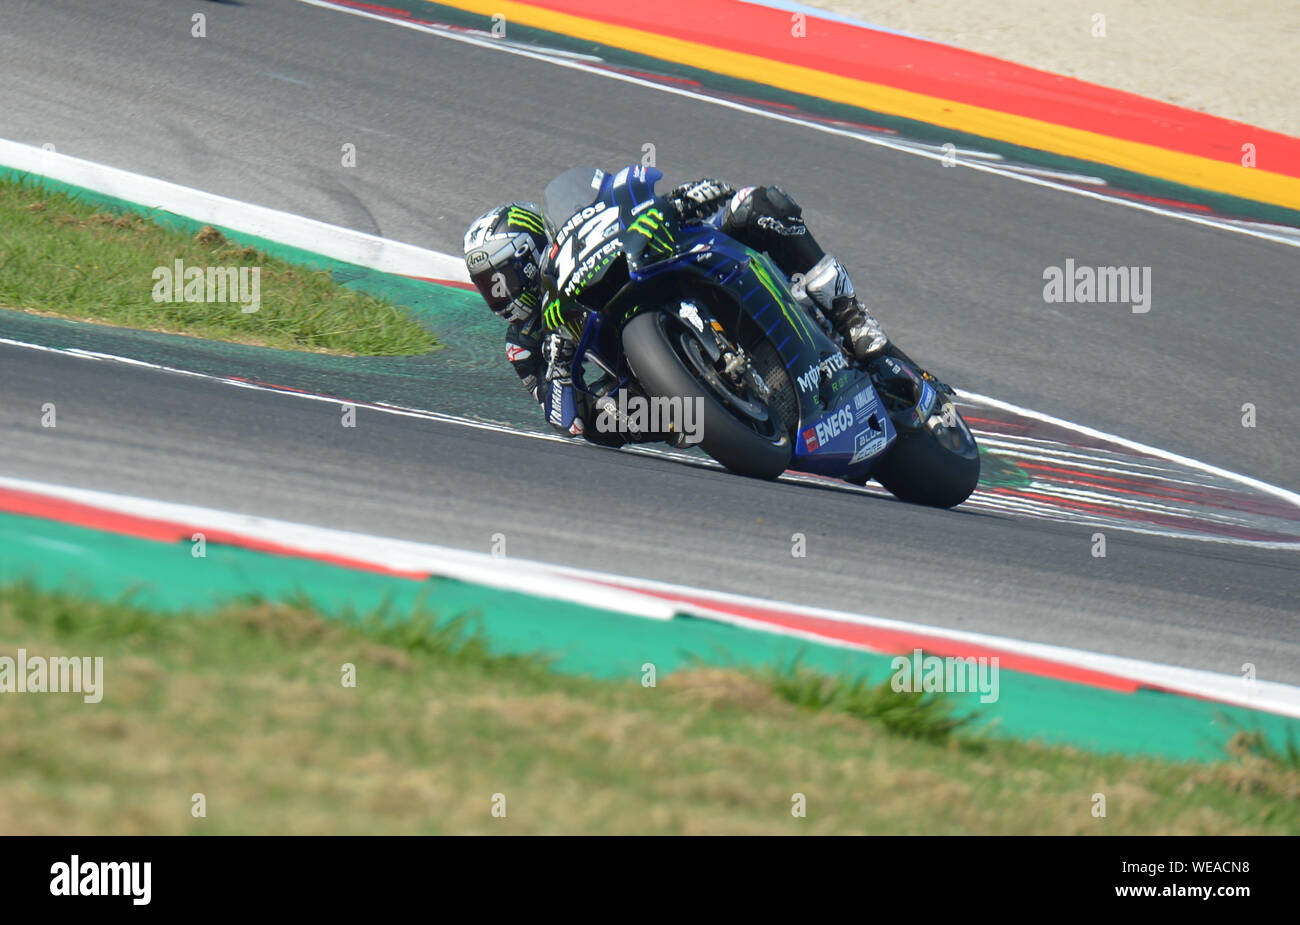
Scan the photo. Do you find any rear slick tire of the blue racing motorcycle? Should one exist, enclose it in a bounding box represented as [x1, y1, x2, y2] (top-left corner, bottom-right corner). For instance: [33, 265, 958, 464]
[871, 401, 979, 508]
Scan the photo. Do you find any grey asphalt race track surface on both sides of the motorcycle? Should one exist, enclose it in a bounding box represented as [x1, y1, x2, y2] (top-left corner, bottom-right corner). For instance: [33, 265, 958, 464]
[0, 0, 1300, 683]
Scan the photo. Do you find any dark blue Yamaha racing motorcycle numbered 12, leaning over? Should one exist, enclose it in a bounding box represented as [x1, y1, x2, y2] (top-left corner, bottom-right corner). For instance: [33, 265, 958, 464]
[542, 166, 980, 508]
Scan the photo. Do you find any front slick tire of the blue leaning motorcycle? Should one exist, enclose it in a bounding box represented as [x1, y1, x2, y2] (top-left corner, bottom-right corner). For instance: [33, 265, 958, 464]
[623, 312, 794, 478]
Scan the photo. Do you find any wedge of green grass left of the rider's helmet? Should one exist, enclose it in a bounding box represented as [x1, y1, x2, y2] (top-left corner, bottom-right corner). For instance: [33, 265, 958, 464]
[0, 179, 437, 356]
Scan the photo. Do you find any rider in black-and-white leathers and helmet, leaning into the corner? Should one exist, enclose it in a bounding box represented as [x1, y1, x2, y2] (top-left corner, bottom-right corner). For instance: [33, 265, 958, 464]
[464, 179, 889, 446]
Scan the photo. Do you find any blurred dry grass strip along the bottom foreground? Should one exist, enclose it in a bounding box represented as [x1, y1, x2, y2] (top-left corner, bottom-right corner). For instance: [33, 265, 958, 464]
[0, 586, 1300, 834]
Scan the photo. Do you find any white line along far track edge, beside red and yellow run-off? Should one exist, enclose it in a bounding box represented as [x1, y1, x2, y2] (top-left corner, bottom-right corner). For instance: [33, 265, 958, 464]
[298, 0, 1300, 247]
